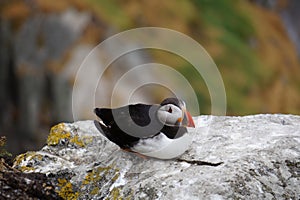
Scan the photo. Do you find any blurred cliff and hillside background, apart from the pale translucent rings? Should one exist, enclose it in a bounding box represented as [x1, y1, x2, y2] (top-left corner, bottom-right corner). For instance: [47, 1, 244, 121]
[0, 0, 300, 154]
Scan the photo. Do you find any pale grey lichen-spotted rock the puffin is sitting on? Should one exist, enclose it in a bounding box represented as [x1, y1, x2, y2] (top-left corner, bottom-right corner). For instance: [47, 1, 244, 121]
[14, 114, 300, 199]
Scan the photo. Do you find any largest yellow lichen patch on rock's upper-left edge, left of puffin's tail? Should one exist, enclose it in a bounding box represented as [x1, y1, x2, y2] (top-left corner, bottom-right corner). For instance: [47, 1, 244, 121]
[47, 123, 71, 146]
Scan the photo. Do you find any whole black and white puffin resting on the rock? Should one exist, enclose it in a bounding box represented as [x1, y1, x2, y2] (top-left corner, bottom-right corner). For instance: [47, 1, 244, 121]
[94, 97, 195, 159]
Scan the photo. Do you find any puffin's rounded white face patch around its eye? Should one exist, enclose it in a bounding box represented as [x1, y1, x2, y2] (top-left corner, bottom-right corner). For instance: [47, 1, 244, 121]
[157, 104, 184, 125]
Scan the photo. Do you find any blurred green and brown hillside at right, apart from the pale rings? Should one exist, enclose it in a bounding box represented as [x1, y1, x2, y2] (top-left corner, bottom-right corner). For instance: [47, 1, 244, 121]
[80, 0, 300, 115]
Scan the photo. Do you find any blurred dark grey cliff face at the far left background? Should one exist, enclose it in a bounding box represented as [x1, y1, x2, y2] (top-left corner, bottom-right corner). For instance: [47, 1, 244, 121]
[0, 2, 96, 153]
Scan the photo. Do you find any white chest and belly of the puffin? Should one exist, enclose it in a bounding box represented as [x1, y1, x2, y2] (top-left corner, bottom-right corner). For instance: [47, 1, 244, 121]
[132, 133, 192, 159]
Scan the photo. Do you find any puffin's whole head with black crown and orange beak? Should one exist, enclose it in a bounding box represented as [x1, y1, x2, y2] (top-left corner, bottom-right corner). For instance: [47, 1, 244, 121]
[157, 98, 195, 127]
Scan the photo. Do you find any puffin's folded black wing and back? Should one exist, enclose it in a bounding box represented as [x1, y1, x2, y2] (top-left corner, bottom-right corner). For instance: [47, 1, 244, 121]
[94, 104, 163, 148]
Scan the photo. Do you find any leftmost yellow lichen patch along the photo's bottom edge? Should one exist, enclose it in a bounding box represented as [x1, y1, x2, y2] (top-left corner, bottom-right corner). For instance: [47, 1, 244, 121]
[56, 178, 79, 200]
